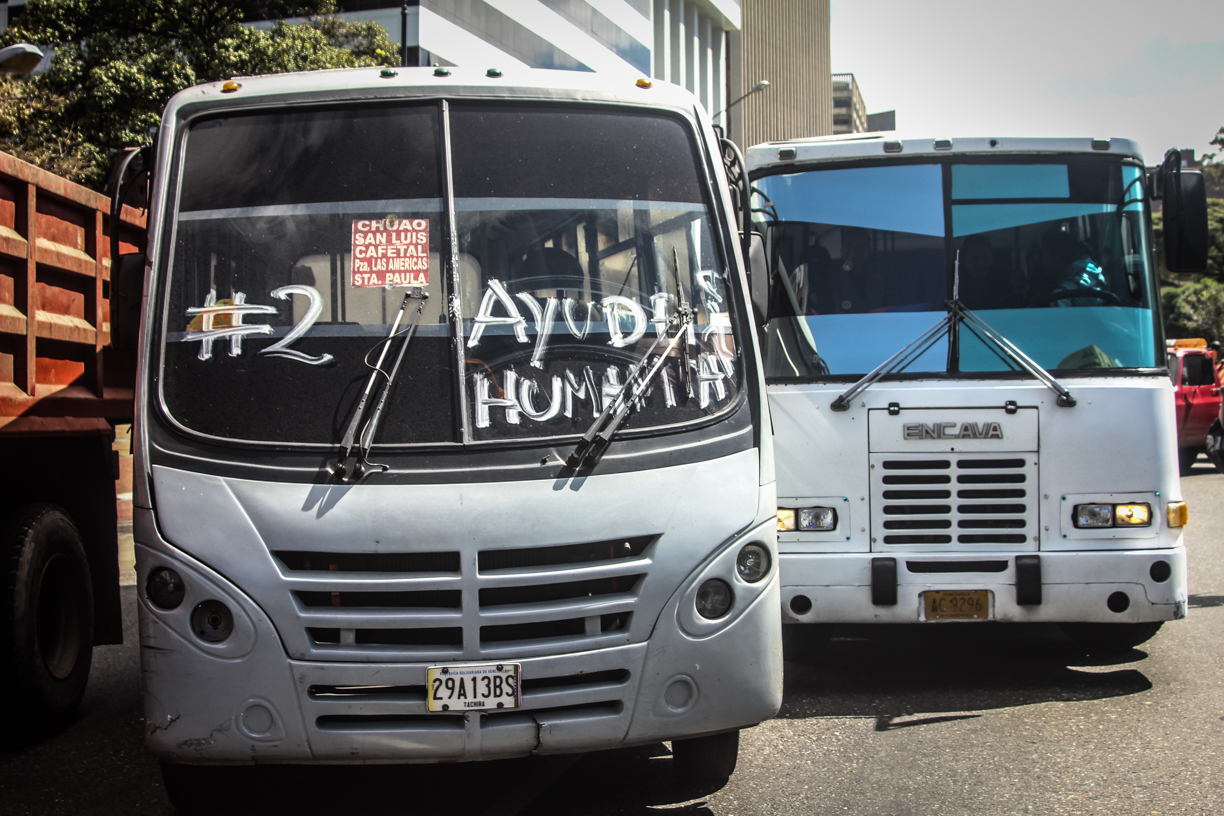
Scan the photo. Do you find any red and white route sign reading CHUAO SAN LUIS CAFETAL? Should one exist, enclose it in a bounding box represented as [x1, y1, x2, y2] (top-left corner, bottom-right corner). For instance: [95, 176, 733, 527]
[353, 215, 430, 286]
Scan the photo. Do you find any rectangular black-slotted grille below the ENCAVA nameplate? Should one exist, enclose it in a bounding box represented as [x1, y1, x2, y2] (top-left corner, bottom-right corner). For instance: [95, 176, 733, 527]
[870, 451, 1038, 552]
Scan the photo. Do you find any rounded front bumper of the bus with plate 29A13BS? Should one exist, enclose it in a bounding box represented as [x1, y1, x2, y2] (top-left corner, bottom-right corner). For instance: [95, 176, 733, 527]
[137, 544, 782, 765]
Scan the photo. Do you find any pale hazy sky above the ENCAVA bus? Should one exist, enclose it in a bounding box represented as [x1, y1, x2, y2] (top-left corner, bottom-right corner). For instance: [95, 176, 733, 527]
[831, 0, 1224, 164]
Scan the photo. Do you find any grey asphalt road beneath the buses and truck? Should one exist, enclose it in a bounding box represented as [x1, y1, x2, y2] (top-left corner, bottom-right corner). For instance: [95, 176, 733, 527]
[0, 462, 1224, 816]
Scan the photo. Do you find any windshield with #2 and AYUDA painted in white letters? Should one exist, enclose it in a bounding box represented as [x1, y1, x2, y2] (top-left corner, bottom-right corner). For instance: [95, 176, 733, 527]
[160, 102, 741, 445]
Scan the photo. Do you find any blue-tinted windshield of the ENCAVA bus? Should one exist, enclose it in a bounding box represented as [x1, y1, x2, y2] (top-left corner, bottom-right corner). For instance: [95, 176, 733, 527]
[754, 157, 1160, 379]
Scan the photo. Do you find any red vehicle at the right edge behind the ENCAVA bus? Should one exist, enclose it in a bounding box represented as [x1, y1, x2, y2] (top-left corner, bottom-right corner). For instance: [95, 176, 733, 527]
[1169, 338, 1224, 475]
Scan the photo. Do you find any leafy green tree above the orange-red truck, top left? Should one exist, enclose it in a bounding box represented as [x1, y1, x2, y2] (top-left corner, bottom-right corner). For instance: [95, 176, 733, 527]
[0, 0, 398, 190]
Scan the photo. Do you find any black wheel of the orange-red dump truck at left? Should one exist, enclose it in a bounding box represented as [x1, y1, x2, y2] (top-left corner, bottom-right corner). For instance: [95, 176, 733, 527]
[0, 504, 93, 730]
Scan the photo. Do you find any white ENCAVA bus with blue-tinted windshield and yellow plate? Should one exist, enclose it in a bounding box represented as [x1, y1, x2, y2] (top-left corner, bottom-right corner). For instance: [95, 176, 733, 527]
[748, 133, 1206, 650]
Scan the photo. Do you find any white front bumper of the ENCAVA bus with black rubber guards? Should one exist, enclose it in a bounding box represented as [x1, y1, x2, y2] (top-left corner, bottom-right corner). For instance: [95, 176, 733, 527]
[780, 546, 1186, 624]
